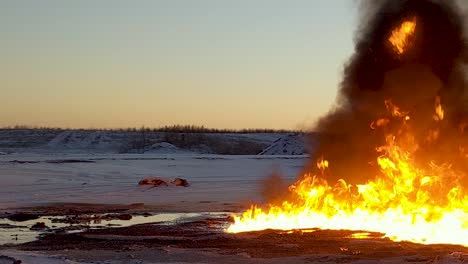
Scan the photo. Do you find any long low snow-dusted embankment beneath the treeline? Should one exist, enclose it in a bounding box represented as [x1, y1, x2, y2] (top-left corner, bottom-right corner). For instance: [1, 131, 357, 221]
[0, 129, 306, 155]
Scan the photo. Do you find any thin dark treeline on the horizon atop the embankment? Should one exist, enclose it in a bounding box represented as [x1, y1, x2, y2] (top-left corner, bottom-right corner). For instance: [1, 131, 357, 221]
[0, 125, 304, 133]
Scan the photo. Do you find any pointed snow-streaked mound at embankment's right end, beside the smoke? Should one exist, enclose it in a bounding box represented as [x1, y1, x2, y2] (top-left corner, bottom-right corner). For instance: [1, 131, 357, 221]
[259, 134, 307, 155]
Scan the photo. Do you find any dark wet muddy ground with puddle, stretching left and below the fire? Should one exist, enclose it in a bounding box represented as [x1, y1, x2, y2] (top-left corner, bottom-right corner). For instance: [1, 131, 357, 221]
[0, 205, 468, 263]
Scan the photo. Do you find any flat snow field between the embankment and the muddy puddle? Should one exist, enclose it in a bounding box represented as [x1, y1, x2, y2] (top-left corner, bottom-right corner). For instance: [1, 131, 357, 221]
[0, 153, 306, 211]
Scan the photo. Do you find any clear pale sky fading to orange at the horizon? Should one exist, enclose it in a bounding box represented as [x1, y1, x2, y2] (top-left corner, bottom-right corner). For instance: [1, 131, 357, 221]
[0, 0, 357, 129]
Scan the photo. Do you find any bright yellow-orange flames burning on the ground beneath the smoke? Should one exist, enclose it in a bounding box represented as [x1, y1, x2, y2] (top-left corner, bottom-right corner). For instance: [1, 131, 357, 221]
[227, 98, 468, 246]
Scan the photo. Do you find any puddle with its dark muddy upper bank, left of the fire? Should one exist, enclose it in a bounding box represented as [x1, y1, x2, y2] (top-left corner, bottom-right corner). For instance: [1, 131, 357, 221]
[0, 204, 229, 245]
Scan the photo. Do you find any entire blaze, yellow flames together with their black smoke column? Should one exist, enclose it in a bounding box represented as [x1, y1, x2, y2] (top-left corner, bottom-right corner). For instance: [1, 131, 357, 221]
[227, 0, 468, 246]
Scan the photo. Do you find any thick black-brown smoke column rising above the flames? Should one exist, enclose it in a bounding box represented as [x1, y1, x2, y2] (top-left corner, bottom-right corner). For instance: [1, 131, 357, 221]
[306, 0, 468, 186]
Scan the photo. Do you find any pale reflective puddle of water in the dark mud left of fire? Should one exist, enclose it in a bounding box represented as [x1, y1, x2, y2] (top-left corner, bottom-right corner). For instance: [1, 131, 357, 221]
[0, 212, 226, 245]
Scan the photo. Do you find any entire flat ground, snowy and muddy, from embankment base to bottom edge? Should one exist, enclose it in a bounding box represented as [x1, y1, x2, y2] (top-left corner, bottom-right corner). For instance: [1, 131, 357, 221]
[0, 153, 468, 264]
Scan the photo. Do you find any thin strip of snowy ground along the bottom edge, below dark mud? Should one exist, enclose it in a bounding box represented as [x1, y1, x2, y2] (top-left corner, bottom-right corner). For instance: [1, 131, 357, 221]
[0, 248, 468, 264]
